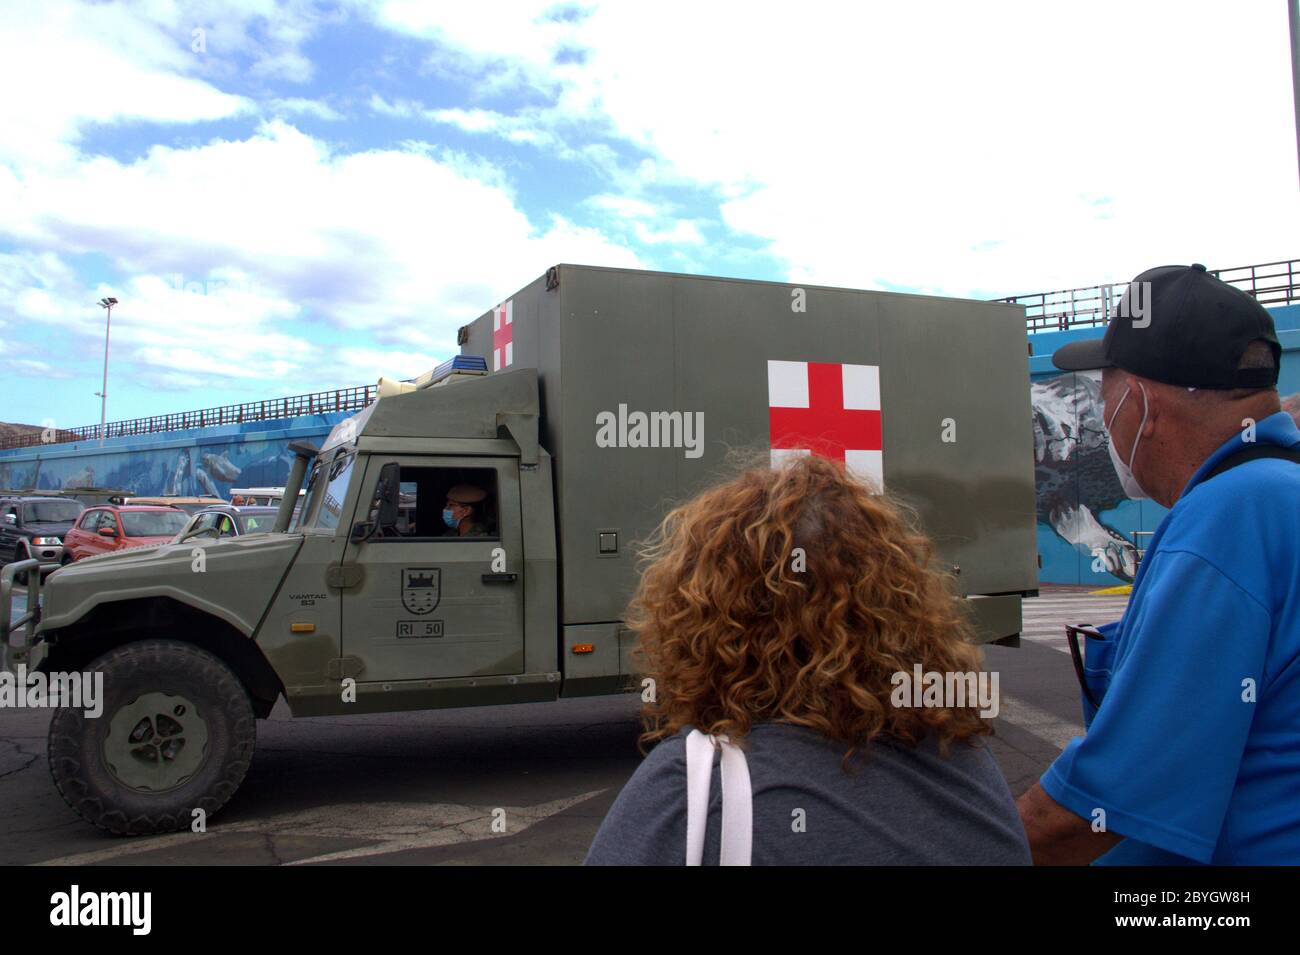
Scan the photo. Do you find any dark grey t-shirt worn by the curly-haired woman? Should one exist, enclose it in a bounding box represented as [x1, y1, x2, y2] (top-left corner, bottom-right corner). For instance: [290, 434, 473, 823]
[586, 722, 1030, 865]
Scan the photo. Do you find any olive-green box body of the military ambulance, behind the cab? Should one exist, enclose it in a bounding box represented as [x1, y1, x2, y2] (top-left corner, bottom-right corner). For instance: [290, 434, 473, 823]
[460, 265, 1037, 637]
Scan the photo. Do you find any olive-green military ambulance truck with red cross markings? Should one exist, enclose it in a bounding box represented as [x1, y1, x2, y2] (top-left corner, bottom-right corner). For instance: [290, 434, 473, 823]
[0, 265, 1037, 833]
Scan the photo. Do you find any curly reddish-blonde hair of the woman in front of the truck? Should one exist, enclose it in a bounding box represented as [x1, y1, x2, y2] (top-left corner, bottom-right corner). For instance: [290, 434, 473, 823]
[627, 455, 992, 767]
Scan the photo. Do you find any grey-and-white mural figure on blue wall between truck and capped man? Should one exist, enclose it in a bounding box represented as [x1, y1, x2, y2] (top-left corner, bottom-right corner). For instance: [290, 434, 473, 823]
[1030, 372, 1300, 583]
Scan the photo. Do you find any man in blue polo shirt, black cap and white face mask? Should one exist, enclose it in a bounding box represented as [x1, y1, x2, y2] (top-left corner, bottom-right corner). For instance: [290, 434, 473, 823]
[1019, 265, 1300, 865]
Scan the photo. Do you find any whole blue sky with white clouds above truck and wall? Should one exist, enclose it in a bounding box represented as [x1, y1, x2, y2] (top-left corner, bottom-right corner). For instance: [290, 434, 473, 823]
[0, 0, 1300, 426]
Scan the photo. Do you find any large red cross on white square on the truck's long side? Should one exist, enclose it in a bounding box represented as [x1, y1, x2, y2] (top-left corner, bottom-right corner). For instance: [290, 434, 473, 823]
[767, 361, 884, 489]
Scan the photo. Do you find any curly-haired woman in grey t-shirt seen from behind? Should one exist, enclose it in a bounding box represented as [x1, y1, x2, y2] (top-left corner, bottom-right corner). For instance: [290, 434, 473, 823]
[586, 456, 1030, 865]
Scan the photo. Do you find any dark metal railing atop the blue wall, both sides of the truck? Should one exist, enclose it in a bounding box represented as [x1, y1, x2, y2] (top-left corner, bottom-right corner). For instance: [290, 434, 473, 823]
[0, 259, 1300, 448]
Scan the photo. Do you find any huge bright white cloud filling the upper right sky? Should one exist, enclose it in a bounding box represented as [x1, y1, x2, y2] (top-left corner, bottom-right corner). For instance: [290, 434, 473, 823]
[378, 0, 1300, 295]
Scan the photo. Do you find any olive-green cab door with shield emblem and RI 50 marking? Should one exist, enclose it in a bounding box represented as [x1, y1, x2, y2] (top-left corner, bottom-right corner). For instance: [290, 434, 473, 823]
[341, 453, 524, 683]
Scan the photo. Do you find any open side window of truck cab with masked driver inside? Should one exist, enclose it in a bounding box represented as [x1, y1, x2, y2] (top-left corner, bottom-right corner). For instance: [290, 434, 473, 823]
[371, 465, 501, 541]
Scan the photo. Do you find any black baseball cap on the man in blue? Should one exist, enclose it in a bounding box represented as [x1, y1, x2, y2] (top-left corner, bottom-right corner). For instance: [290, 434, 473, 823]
[1052, 264, 1282, 388]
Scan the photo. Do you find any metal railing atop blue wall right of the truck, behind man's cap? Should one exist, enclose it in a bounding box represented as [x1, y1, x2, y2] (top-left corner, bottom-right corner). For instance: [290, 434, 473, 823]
[996, 259, 1300, 331]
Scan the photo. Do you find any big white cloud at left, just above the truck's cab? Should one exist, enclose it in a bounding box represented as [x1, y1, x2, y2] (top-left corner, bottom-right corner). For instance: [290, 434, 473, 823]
[0, 121, 640, 387]
